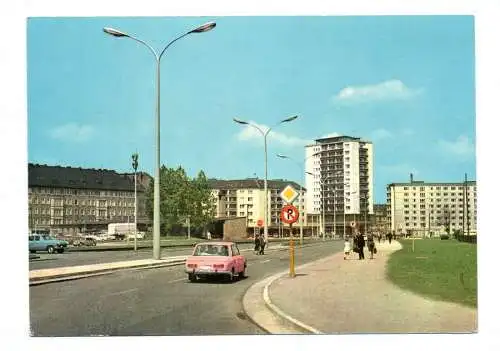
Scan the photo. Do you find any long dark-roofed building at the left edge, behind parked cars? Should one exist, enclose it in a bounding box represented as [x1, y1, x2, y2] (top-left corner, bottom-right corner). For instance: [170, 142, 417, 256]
[28, 163, 151, 235]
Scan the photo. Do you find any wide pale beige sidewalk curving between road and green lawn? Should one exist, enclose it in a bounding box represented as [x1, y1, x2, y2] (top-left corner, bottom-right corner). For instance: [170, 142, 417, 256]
[264, 242, 477, 334]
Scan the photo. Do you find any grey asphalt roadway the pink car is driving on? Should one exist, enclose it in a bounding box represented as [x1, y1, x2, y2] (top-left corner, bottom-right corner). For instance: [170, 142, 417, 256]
[30, 241, 343, 336]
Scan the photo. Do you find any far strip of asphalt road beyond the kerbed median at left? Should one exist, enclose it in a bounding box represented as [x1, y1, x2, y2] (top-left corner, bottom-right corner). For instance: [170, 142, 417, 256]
[29, 244, 258, 270]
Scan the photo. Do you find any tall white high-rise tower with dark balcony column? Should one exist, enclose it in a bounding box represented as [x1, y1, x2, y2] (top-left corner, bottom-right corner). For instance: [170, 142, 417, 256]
[305, 136, 374, 234]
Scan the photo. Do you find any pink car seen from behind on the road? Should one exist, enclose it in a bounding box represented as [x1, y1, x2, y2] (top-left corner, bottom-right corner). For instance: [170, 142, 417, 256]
[185, 241, 247, 282]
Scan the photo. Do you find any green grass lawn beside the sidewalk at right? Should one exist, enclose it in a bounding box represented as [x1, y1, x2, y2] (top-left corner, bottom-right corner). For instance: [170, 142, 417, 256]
[387, 239, 477, 307]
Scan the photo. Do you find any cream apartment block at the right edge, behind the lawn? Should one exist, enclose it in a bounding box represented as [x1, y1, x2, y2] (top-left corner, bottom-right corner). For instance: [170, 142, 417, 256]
[387, 176, 477, 236]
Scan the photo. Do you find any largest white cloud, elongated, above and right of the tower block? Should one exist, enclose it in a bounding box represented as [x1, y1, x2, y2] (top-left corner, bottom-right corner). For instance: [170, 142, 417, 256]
[333, 79, 422, 103]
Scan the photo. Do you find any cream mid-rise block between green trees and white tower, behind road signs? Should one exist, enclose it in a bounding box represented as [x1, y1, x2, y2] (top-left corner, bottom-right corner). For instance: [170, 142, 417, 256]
[208, 178, 307, 234]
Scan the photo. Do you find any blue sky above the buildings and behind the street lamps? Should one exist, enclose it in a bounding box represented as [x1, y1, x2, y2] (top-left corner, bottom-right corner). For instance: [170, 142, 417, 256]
[27, 16, 475, 203]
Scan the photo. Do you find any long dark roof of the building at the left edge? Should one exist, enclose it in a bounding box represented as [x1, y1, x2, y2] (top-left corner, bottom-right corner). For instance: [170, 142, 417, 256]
[28, 163, 151, 191]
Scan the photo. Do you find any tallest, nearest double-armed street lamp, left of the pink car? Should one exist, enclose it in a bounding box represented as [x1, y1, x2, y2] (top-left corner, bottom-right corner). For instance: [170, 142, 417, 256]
[103, 22, 216, 260]
